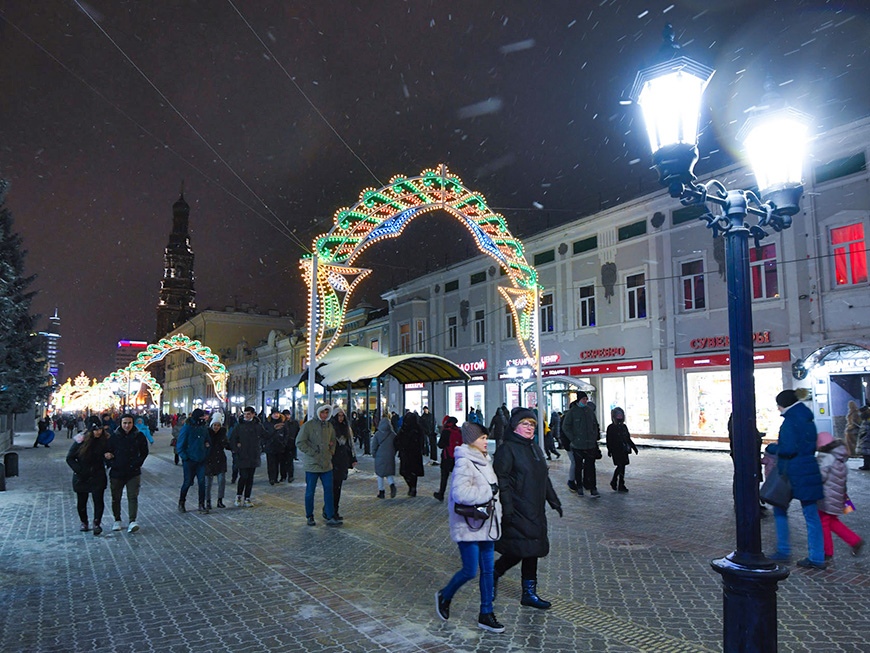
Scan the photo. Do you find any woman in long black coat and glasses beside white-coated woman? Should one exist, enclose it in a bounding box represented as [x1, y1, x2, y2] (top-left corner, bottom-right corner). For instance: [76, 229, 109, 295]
[492, 407, 562, 610]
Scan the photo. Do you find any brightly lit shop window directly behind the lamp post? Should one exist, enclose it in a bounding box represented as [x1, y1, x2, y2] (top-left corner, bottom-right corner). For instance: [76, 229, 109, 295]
[688, 368, 782, 437]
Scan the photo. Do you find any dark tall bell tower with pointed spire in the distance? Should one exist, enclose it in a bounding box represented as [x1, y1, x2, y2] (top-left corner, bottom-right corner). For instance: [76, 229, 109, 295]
[155, 186, 196, 342]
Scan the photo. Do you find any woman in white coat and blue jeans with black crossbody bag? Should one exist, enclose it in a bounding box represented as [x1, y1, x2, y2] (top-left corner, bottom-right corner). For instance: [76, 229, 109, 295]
[435, 422, 504, 633]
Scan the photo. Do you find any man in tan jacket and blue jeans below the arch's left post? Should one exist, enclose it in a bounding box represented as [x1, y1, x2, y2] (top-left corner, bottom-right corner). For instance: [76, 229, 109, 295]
[296, 404, 341, 526]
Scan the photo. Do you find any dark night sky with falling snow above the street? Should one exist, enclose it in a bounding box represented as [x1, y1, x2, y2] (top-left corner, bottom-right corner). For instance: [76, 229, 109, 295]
[0, 0, 870, 381]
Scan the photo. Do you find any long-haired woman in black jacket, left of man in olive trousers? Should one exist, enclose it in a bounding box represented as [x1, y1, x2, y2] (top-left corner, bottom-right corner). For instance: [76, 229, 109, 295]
[66, 417, 109, 535]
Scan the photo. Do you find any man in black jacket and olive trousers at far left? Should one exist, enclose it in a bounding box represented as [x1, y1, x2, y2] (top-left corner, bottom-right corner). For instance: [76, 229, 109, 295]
[106, 413, 148, 533]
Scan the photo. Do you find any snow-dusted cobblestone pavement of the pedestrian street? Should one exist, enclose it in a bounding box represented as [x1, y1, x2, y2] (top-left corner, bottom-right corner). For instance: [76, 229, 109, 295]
[0, 430, 870, 653]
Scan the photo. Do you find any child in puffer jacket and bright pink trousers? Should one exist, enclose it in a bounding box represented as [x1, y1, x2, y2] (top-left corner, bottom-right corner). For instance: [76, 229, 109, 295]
[816, 431, 864, 560]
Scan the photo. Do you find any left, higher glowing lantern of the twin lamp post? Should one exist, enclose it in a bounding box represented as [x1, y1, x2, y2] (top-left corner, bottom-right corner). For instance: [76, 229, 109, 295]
[631, 57, 715, 186]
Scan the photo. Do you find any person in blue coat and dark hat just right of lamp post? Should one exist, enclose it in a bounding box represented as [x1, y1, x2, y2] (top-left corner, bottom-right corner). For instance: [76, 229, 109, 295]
[767, 390, 827, 569]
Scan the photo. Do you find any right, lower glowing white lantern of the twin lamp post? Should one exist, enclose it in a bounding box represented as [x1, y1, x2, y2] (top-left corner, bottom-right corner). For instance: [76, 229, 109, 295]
[737, 107, 810, 215]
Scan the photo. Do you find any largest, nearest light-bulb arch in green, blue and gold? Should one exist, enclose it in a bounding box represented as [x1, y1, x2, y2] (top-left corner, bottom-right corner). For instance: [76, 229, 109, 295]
[300, 164, 540, 359]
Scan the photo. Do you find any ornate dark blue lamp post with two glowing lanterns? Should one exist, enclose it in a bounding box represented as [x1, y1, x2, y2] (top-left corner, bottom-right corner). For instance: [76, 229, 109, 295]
[632, 25, 808, 653]
